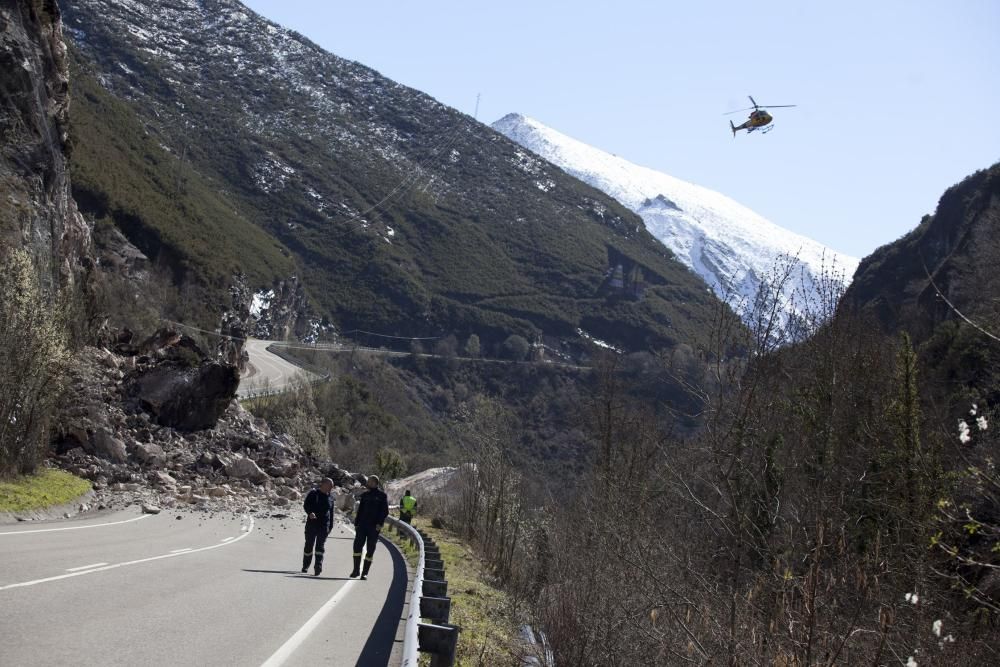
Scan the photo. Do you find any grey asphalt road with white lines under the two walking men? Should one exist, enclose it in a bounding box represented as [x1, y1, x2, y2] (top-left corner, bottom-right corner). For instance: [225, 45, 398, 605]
[0, 510, 407, 667]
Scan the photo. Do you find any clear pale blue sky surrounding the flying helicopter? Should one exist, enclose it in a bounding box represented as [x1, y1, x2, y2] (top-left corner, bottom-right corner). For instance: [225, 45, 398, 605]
[238, 0, 1000, 256]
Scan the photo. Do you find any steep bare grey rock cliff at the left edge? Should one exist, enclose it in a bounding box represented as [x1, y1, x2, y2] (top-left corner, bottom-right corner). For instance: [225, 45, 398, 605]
[0, 0, 92, 288]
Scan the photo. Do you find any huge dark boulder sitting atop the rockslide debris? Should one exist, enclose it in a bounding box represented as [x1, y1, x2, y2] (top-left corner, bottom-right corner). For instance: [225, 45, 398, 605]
[128, 362, 240, 431]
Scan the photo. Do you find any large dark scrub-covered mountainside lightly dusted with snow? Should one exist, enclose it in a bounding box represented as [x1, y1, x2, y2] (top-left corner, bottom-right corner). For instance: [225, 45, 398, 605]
[65, 0, 718, 349]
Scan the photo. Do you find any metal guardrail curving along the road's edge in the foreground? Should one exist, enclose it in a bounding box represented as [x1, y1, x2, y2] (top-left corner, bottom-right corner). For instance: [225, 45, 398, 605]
[386, 516, 461, 667]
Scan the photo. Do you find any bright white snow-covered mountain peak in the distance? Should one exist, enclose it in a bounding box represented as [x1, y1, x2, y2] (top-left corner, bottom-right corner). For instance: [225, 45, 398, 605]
[493, 113, 858, 328]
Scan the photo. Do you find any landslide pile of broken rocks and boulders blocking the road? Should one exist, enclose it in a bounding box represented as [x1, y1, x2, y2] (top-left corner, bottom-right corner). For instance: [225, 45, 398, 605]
[53, 331, 364, 515]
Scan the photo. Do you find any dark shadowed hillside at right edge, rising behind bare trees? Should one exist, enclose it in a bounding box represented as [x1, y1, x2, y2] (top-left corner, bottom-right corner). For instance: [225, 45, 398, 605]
[841, 163, 1000, 404]
